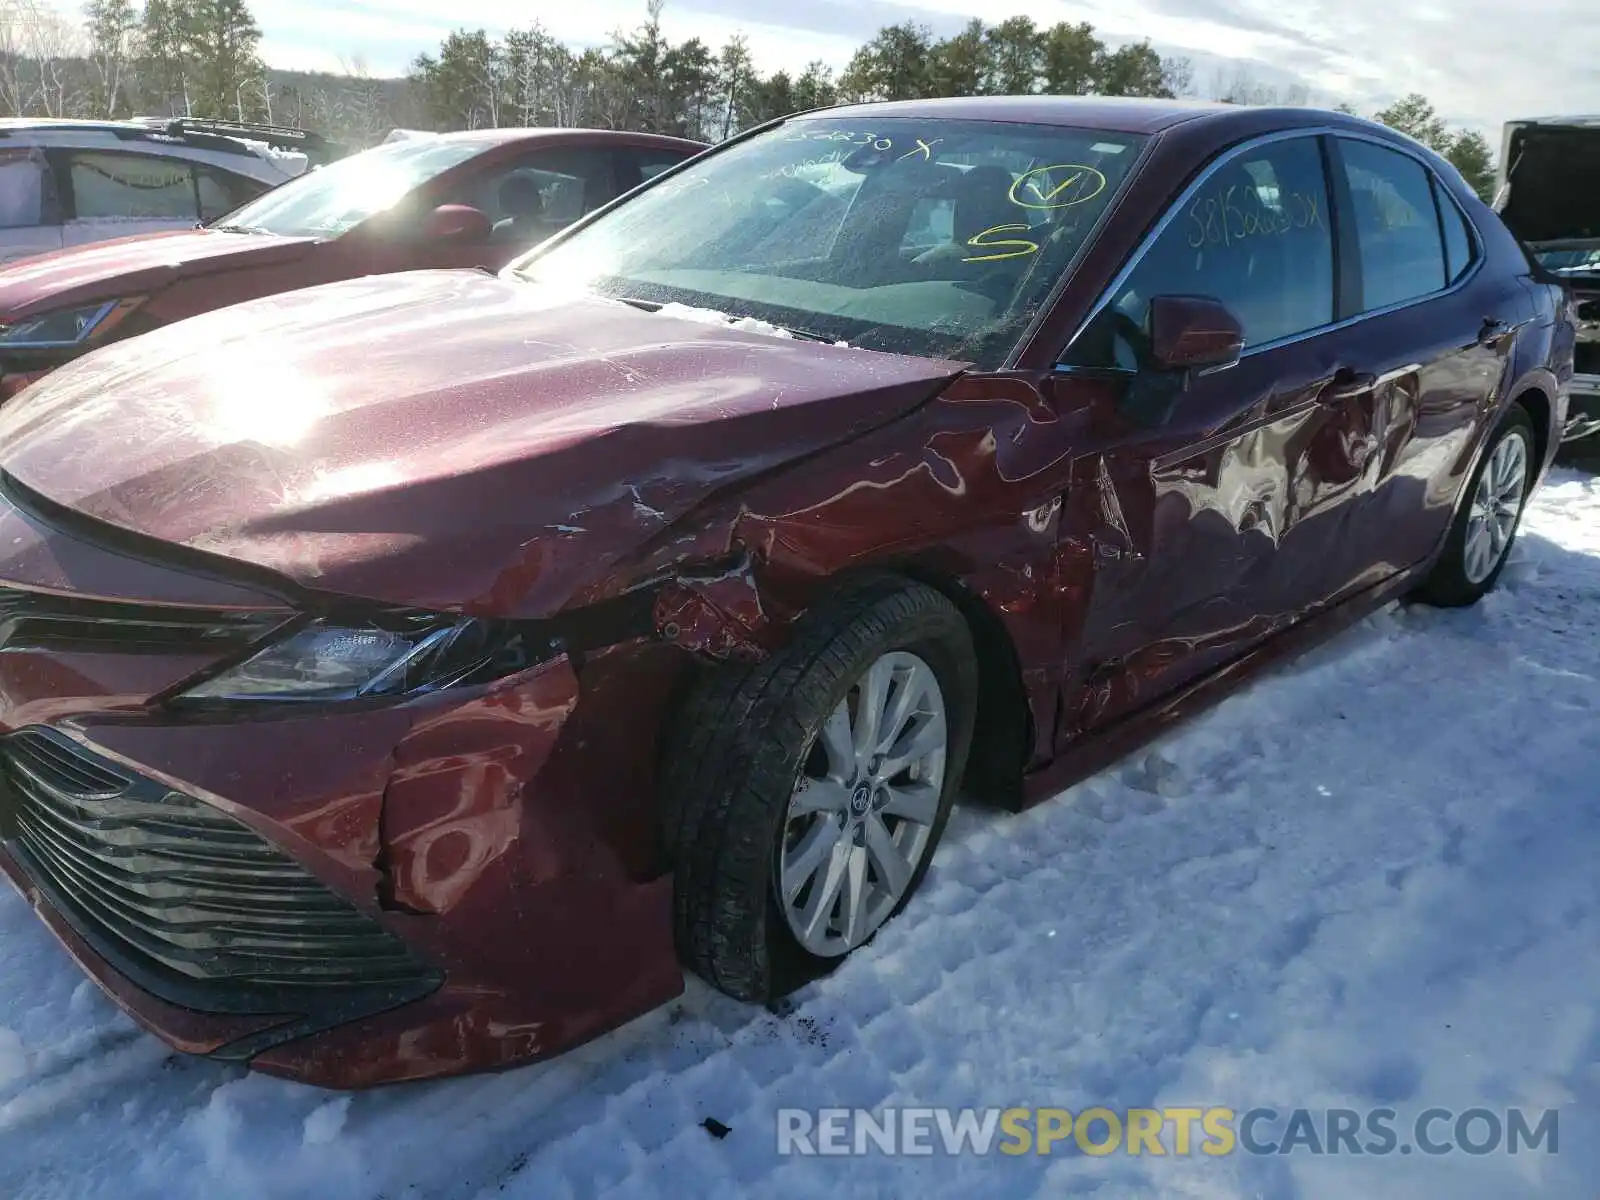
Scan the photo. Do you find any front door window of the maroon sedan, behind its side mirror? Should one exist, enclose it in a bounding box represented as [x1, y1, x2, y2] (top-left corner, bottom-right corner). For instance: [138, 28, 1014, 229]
[1066, 138, 1334, 371]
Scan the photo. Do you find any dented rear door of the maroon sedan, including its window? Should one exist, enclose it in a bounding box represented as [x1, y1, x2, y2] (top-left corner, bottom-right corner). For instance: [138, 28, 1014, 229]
[1331, 136, 1533, 579]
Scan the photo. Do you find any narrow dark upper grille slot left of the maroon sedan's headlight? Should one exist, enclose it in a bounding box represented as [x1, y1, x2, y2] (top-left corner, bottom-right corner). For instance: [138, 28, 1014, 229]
[0, 586, 291, 654]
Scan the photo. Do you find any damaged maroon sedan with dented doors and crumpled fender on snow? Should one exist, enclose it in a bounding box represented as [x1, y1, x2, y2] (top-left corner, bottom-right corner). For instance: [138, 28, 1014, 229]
[0, 98, 1574, 1086]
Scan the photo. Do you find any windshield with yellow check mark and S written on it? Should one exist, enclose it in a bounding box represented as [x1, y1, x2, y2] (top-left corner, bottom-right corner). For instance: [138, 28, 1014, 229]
[510, 117, 1144, 366]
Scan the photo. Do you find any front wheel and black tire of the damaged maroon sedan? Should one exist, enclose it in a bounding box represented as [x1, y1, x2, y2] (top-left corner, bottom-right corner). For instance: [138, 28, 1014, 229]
[662, 578, 978, 1002]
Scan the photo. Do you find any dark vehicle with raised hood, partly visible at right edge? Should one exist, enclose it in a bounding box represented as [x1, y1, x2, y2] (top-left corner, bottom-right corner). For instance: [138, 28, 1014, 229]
[1496, 117, 1600, 442]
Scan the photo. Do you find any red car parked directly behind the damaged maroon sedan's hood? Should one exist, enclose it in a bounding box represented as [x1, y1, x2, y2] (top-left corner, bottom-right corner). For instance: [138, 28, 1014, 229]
[0, 122, 706, 398]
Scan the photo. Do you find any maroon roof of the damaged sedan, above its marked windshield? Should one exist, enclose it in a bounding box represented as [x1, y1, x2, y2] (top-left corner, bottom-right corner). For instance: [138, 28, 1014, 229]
[787, 96, 1368, 133]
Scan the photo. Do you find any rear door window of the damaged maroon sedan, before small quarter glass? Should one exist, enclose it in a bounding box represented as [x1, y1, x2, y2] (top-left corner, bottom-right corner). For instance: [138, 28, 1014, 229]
[1339, 138, 1448, 312]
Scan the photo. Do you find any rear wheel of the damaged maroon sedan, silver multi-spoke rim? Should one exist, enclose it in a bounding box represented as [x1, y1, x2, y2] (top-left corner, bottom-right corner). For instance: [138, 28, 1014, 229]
[1418, 405, 1538, 608]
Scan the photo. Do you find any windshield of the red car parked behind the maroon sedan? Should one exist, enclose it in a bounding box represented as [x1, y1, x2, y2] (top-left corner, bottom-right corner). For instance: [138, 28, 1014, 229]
[213, 138, 485, 237]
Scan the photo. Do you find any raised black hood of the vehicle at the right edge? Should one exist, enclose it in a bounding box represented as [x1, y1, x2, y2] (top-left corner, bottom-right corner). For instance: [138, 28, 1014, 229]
[1498, 120, 1600, 259]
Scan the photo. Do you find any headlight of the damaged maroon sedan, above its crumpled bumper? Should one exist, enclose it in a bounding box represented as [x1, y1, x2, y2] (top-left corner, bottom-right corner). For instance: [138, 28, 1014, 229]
[179, 618, 502, 701]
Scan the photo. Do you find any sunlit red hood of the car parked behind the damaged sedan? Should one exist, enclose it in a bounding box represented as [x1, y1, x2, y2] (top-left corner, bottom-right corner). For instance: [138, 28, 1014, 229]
[0, 229, 317, 320]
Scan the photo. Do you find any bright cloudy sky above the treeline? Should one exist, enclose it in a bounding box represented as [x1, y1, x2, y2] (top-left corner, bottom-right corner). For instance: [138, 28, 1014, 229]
[232, 0, 1600, 134]
